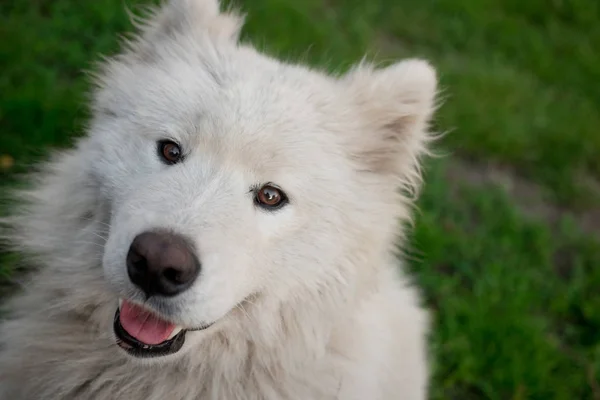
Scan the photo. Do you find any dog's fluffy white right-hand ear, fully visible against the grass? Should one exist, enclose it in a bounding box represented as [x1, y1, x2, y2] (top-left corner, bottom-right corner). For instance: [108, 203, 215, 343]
[342, 59, 437, 185]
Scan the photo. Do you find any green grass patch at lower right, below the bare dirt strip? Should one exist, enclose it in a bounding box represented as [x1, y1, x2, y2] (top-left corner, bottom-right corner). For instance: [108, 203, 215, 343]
[412, 161, 600, 400]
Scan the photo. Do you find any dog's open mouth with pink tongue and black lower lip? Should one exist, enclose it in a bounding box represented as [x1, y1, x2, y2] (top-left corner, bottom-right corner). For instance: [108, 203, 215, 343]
[113, 300, 210, 358]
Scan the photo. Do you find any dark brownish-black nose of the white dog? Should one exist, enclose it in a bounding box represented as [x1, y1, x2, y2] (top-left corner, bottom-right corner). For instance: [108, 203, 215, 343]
[127, 232, 200, 297]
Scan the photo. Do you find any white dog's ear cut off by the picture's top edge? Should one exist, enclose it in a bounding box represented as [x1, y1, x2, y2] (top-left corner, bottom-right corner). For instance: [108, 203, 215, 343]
[139, 0, 243, 43]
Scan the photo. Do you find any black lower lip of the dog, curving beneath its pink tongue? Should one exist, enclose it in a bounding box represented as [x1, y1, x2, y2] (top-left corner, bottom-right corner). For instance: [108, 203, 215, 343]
[113, 308, 210, 358]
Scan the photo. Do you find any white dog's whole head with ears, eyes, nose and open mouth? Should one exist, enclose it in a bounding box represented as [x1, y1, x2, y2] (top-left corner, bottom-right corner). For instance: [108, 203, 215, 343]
[84, 0, 435, 357]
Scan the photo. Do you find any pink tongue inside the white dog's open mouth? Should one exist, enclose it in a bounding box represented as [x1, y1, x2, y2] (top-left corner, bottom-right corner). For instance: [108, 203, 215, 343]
[120, 300, 175, 344]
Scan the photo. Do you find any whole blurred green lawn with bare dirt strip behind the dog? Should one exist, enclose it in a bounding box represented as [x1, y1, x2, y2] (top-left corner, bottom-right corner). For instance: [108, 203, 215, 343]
[0, 0, 600, 400]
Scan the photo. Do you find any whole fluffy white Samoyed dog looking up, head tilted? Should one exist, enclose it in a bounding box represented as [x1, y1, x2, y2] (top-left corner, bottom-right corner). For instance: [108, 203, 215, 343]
[0, 0, 436, 400]
